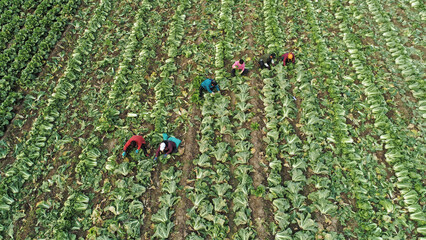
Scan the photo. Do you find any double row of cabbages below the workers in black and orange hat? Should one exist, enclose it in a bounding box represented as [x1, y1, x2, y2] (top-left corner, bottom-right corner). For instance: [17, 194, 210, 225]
[262, 2, 331, 239]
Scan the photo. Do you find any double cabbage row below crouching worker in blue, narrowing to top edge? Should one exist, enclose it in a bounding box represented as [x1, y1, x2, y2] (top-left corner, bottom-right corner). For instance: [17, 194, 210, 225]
[186, 0, 233, 240]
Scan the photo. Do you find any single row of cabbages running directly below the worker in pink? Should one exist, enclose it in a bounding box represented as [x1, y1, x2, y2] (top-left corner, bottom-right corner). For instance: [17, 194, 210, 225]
[229, 2, 267, 236]
